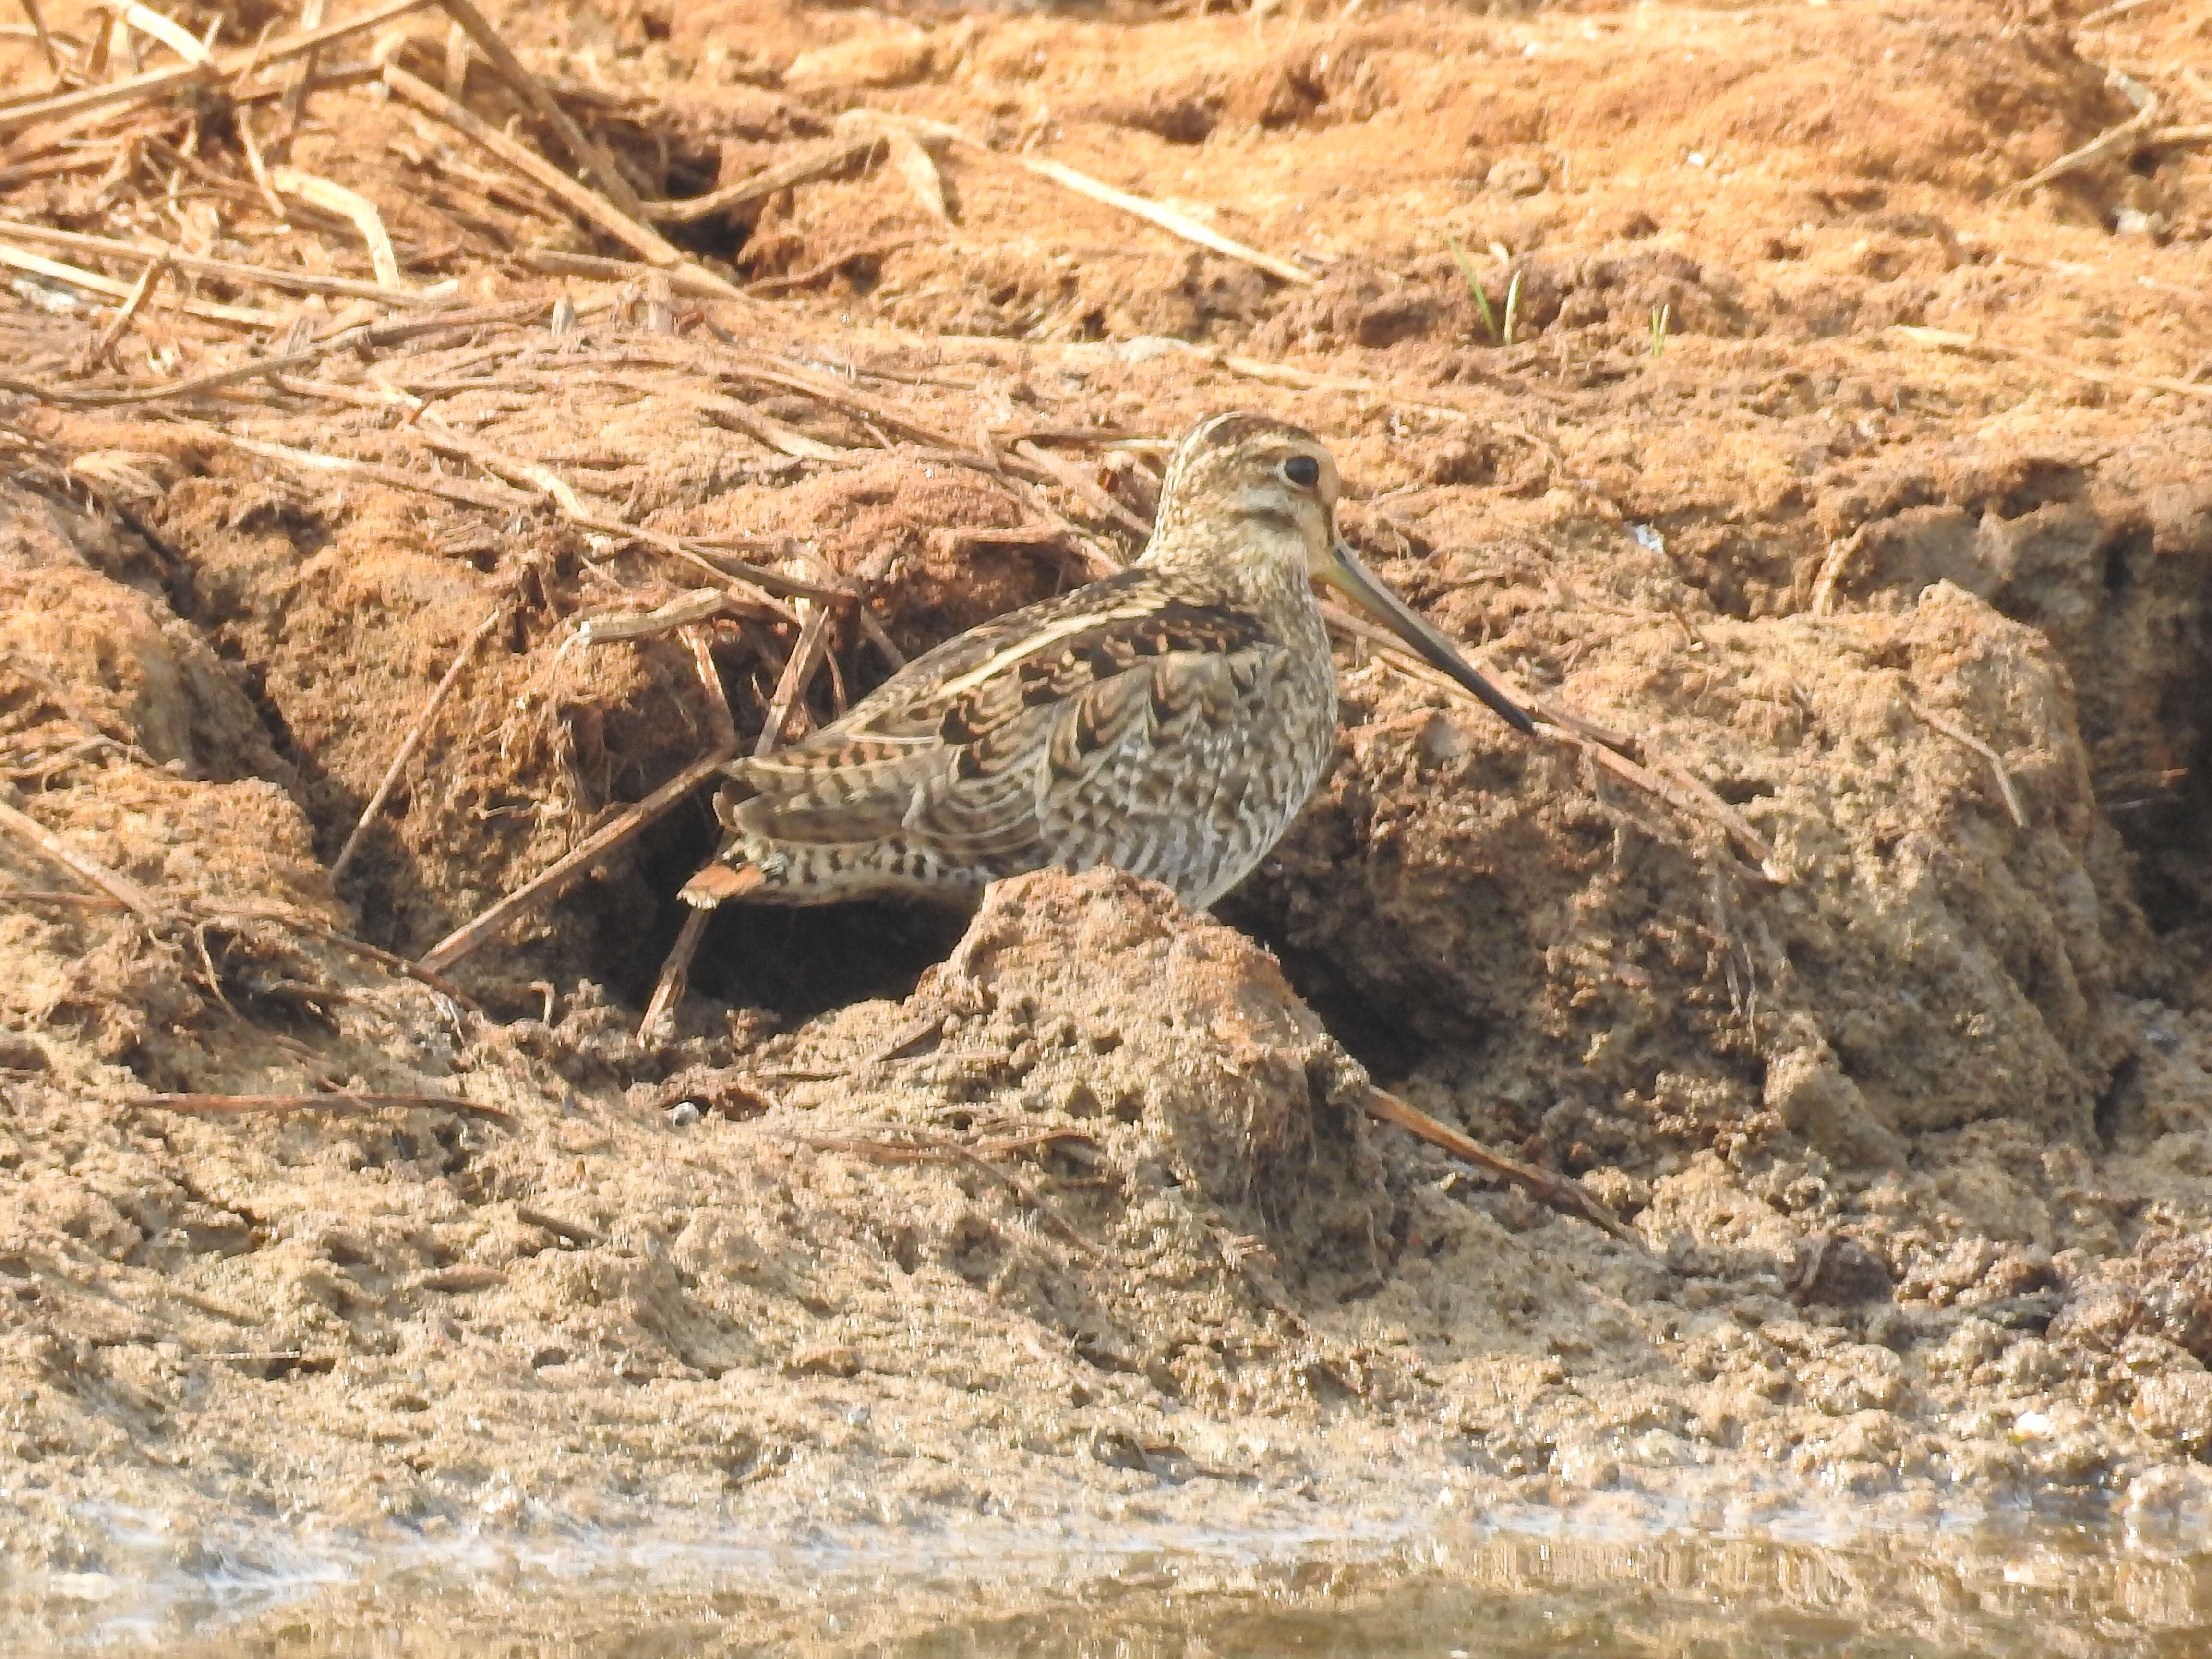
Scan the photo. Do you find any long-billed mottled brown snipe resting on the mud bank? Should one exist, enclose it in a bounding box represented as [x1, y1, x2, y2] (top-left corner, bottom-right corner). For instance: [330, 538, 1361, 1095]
[684, 411, 1533, 909]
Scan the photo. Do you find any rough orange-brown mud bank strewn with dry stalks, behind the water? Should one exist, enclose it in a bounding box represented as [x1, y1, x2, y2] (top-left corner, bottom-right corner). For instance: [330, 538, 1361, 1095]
[0, 4, 2212, 1636]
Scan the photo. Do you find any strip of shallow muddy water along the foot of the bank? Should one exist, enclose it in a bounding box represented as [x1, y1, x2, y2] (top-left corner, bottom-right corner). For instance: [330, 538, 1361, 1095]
[0, 1513, 2212, 1659]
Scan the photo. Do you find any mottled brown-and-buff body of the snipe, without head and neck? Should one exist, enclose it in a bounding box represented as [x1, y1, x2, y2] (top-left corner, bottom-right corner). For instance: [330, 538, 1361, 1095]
[717, 566, 1336, 907]
